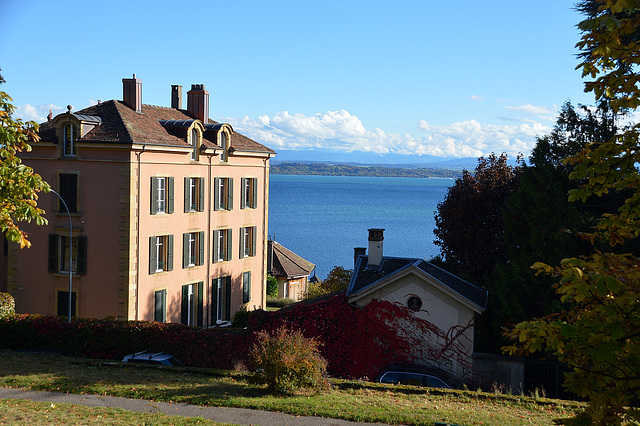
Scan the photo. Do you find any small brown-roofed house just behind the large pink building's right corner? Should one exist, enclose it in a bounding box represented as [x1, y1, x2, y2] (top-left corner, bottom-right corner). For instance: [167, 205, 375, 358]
[267, 239, 316, 300]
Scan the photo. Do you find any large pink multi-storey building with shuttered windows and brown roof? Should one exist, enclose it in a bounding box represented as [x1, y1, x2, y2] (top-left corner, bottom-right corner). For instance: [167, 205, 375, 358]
[6, 75, 274, 326]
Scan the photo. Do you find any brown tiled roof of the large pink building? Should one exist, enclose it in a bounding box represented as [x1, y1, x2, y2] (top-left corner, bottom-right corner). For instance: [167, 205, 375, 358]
[40, 100, 274, 154]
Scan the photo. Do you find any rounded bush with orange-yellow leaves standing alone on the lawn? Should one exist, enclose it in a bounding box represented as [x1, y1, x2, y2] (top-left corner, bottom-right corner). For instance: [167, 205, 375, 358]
[249, 327, 328, 395]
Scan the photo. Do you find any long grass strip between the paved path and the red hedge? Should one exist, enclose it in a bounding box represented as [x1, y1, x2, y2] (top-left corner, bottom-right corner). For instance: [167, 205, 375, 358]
[0, 351, 581, 425]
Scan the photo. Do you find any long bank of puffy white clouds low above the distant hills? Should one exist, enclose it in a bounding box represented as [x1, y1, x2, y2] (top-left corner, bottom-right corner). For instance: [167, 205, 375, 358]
[223, 110, 551, 157]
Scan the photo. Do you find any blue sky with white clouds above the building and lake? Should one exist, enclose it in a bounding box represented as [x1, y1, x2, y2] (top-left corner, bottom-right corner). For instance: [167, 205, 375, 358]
[0, 0, 593, 163]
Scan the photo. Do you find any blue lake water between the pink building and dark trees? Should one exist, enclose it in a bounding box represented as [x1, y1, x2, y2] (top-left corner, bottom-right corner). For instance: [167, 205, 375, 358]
[269, 175, 454, 278]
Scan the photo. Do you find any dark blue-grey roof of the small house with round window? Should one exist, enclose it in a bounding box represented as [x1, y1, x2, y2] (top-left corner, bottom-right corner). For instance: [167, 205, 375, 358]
[347, 256, 488, 310]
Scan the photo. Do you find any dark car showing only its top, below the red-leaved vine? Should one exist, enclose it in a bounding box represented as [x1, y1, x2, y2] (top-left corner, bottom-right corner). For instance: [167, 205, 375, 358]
[376, 365, 462, 389]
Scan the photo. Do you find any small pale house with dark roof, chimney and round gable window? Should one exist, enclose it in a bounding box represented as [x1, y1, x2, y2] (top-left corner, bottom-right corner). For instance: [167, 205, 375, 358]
[346, 228, 488, 378]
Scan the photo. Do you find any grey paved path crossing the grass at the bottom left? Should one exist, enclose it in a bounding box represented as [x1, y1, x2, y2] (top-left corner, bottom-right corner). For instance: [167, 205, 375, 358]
[0, 387, 382, 426]
